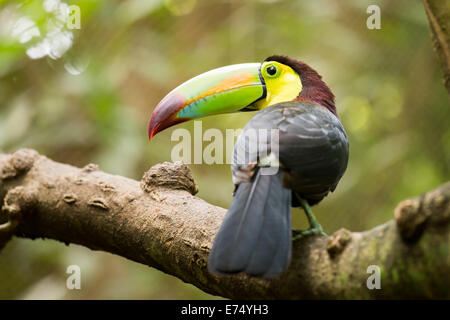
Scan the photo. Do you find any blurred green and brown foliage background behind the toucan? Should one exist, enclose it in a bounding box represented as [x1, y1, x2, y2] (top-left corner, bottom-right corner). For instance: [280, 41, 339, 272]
[0, 0, 450, 299]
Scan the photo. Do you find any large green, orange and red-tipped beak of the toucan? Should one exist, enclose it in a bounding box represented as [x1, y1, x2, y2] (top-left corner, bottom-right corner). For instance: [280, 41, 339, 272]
[148, 63, 266, 140]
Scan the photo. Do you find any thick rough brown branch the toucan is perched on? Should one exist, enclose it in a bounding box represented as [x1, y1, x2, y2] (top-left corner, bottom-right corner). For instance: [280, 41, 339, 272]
[0, 150, 450, 299]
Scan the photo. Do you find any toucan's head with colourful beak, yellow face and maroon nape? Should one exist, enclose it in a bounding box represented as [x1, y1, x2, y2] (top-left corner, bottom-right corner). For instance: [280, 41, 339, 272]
[148, 55, 336, 139]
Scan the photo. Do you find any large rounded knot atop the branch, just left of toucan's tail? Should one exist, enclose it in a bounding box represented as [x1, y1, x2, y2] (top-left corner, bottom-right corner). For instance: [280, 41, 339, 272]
[141, 161, 198, 195]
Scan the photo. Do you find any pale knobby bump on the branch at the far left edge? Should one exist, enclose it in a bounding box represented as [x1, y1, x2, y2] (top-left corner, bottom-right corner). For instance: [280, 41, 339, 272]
[0, 149, 39, 180]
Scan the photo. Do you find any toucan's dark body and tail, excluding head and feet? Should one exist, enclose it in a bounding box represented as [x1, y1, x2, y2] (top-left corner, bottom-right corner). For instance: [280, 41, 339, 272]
[208, 101, 348, 277]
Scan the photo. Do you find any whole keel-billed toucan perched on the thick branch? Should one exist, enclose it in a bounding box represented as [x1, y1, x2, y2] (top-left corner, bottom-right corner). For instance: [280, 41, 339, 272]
[148, 55, 349, 278]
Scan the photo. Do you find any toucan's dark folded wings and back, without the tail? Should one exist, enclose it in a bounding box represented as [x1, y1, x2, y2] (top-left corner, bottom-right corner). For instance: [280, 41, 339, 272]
[232, 101, 348, 204]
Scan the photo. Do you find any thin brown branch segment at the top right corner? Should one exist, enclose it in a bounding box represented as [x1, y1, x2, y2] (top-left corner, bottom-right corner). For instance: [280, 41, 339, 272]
[423, 0, 450, 94]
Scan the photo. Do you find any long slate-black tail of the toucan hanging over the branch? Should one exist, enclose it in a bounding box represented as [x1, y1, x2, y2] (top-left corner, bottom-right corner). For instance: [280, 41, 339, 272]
[208, 170, 291, 277]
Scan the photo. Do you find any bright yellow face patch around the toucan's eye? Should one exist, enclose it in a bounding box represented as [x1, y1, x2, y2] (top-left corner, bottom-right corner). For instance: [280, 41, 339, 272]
[254, 61, 302, 110]
